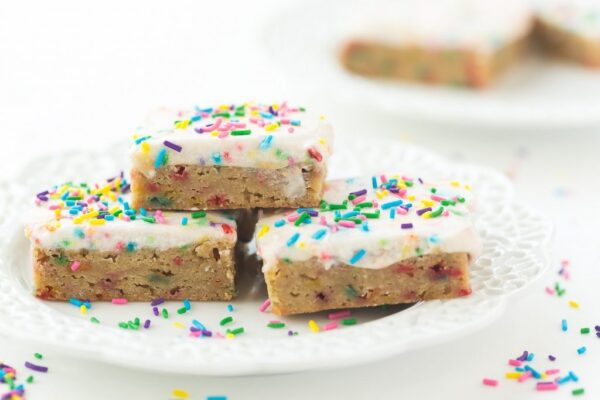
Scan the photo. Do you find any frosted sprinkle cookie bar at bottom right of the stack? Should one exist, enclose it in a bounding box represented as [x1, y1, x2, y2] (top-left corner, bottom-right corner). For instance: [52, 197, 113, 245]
[256, 175, 481, 315]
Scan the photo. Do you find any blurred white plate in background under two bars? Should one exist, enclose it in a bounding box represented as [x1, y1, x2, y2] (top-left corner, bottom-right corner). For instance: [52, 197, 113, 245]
[263, 0, 600, 129]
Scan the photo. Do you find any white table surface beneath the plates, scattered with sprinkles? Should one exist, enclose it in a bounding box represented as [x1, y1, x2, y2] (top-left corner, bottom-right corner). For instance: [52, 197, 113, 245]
[0, 0, 600, 400]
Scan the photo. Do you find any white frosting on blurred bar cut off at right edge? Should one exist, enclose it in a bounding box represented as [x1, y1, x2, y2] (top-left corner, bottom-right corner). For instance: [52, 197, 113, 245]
[537, 0, 600, 40]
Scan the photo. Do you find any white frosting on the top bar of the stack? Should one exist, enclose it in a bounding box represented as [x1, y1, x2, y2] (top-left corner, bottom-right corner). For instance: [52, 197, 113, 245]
[130, 103, 333, 176]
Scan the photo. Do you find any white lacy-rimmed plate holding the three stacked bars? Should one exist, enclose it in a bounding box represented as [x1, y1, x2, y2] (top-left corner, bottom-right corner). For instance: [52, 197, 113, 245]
[0, 142, 552, 376]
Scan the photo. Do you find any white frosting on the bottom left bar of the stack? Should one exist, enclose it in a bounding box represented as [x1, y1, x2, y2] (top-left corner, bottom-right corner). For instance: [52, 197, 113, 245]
[26, 180, 236, 251]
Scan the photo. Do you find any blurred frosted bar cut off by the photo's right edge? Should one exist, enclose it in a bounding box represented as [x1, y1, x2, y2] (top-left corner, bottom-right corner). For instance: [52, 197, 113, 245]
[535, 0, 600, 68]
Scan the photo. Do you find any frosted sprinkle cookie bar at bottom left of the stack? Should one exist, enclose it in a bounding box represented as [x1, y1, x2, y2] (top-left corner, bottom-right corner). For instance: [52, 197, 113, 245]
[26, 177, 237, 301]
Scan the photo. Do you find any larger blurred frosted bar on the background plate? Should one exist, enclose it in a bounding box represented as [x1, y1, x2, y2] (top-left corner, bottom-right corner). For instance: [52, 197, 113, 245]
[341, 0, 533, 87]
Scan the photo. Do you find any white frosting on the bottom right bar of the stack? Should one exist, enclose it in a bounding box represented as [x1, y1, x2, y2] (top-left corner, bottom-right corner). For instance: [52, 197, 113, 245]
[257, 177, 481, 271]
